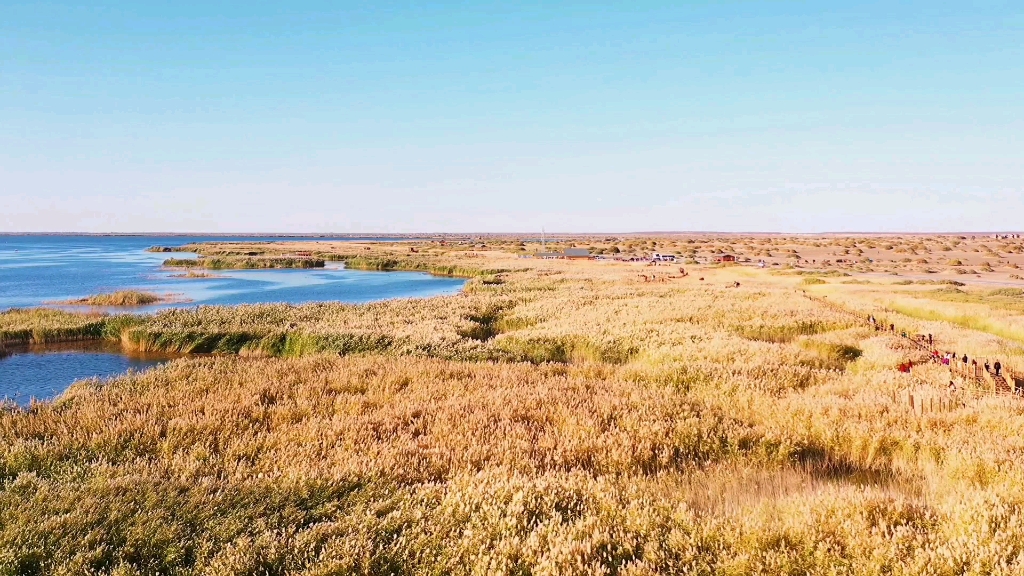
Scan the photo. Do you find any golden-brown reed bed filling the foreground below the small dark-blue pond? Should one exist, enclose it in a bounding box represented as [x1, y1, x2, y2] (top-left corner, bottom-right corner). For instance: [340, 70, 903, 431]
[6, 350, 1024, 574]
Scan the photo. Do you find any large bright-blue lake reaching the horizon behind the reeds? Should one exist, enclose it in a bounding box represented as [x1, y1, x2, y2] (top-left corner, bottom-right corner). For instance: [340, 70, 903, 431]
[0, 236, 463, 312]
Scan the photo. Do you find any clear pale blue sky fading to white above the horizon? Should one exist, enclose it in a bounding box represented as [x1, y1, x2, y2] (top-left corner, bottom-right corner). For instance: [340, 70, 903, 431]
[0, 0, 1024, 234]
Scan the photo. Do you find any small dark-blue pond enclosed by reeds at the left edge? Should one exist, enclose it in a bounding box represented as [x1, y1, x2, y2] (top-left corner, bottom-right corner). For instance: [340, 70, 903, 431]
[0, 342, 170, 406]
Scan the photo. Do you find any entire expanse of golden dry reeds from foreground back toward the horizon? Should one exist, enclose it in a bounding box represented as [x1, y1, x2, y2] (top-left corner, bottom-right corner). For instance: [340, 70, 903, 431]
[6, 239, 1024, 575]
